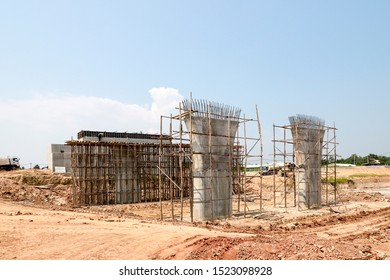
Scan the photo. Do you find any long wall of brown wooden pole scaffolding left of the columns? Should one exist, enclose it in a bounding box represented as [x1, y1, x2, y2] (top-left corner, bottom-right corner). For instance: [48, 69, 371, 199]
[67, 141, 192, 205]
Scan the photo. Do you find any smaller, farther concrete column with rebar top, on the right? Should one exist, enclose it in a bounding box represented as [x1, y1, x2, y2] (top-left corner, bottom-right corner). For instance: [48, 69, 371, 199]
[289, 115, 325, 209]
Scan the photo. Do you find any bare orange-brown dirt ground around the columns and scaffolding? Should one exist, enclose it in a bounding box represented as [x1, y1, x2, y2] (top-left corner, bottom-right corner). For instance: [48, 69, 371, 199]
[0, 167, 390, 260]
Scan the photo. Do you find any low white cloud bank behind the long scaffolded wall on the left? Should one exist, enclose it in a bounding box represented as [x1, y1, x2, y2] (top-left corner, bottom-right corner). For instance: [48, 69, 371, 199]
[0, 87, 183, 164]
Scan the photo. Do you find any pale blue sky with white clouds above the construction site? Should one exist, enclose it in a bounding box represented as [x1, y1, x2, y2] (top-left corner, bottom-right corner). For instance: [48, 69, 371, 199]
[0, 0, 390, 164]
